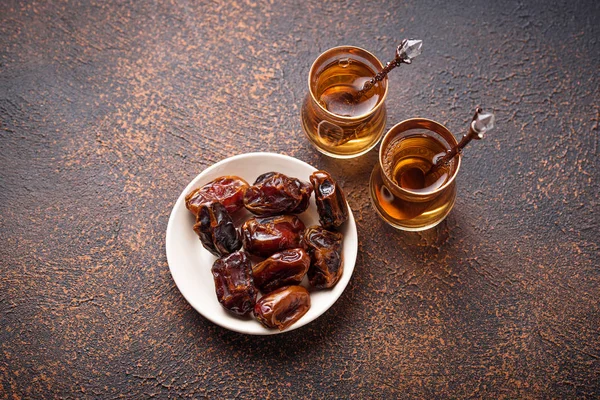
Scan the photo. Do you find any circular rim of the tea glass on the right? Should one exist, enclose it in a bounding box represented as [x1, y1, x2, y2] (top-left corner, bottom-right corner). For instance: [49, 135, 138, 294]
[379, 118, 462, 197]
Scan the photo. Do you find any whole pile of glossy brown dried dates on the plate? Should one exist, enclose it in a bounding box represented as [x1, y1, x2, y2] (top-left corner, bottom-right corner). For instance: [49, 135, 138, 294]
[185, 171, 348, 330]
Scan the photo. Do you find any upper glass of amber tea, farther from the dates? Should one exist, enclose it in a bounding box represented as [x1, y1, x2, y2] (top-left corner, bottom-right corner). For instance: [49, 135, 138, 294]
[302, 46, 388, 158]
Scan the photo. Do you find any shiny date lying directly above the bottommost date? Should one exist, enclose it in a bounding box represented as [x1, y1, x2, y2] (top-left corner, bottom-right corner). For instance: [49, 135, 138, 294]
[252, 248, 310, 293]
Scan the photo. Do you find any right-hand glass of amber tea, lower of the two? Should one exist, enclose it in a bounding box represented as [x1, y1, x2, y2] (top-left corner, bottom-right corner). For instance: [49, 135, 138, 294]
[369, 118, 461, 231]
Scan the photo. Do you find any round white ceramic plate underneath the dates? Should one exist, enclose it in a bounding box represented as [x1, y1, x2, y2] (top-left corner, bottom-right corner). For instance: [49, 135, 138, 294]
[166, 153, 358, 335]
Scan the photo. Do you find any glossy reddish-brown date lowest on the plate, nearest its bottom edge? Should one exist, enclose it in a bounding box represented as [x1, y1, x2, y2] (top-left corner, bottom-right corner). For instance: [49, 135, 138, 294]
[254, 286, 310, 331]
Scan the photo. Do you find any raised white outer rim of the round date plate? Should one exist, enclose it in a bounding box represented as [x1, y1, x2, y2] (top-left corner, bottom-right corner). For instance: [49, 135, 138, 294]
[165, 152, 358, 336]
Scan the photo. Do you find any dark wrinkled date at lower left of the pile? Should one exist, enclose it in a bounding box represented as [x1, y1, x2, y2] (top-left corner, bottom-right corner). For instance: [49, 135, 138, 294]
[212, 250, 258, 315]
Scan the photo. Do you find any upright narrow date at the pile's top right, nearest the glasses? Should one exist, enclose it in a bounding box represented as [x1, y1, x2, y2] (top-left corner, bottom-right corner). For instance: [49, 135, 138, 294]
[310, 171, 348, 229]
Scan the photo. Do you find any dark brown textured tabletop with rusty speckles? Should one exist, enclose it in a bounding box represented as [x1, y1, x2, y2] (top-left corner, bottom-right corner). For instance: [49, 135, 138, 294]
[0, 0, 600, 399]
